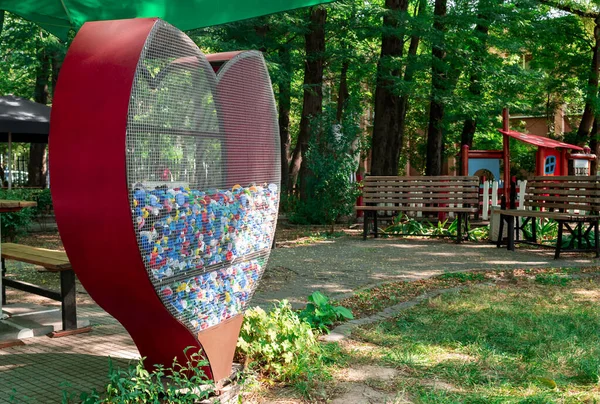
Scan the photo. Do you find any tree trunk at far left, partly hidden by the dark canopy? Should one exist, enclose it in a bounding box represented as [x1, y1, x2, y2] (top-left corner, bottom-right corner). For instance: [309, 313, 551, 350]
[27, 49, 51, 188]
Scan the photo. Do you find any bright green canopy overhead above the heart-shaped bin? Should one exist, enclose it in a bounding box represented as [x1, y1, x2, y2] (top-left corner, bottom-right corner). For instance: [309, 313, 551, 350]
[0, 0, 333, 39]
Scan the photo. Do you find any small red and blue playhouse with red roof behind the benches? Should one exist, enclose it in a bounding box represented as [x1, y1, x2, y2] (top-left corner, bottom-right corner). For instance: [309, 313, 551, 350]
[461, 108, 596, 203]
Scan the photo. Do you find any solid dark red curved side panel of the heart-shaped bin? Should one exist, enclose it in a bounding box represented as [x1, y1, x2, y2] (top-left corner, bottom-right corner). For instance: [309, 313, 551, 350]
[49, 19, 210, 376]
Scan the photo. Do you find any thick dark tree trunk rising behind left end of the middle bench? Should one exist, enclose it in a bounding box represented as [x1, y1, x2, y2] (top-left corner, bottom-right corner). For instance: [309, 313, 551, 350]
[371, 0, 409, 175]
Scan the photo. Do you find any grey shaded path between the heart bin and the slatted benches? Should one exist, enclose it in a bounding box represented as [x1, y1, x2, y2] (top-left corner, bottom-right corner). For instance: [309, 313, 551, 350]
[252, 237, 598, 307]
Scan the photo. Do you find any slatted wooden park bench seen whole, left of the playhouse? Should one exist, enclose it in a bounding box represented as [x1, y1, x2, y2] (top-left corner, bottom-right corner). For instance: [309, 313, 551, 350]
[356, 176, 479, 243]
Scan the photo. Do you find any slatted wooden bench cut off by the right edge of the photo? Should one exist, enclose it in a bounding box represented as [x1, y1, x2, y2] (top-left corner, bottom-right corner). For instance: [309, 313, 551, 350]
[497, 176, 600, 259]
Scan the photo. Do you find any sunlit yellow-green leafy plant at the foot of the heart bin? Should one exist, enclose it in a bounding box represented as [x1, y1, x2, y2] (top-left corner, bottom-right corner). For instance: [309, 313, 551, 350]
[236, 300, 339, 398]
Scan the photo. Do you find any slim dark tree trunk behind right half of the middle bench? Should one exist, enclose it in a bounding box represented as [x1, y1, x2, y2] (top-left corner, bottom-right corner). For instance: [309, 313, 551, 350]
[425, 0, 448, 175]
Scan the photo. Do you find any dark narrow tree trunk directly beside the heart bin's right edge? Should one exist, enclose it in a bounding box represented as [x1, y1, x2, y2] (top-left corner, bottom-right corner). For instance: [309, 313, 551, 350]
[278, 47, 292, 192]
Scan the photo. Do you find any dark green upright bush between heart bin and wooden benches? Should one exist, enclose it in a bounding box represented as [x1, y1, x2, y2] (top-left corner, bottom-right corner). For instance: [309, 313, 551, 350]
[290, 112, 360, 225]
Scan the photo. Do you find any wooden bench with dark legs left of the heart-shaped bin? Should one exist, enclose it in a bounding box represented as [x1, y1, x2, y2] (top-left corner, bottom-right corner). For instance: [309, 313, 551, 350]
[2, 243, 89, 337]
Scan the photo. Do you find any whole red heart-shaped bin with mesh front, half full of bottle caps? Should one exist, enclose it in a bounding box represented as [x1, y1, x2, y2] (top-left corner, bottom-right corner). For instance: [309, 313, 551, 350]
[50, 19, 280, 381]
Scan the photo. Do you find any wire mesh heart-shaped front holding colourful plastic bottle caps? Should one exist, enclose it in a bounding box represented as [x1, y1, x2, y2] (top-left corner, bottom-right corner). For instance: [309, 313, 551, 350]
[126, 21, 280, 332]
